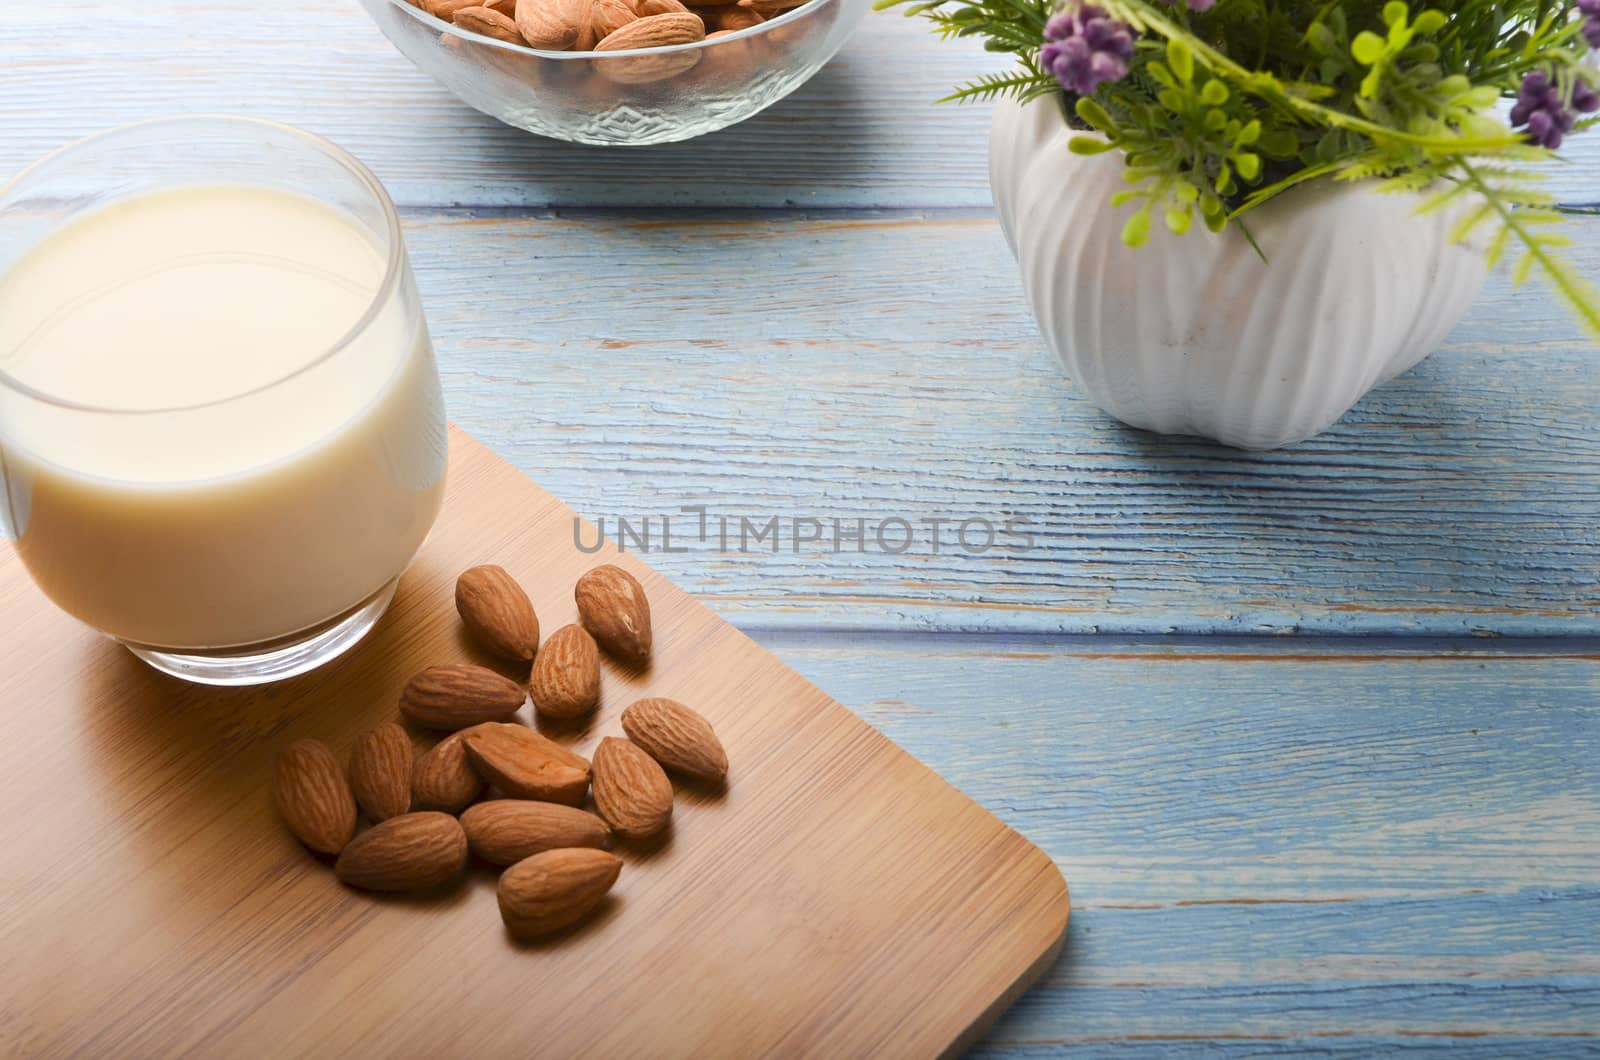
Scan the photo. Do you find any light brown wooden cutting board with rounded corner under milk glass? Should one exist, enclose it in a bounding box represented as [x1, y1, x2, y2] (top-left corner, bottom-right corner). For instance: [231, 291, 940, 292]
[0, 431, 1067, 1060]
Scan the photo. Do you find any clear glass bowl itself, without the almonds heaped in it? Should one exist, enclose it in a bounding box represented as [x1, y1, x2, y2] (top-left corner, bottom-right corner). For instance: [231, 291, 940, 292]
[362, 0, 872, 144]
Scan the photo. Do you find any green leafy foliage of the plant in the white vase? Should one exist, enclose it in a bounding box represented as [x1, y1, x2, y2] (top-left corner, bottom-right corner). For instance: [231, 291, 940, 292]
[878, 0, 1600, 339]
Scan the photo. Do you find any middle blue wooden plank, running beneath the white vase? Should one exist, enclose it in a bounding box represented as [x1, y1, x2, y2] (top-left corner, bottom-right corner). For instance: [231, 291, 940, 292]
[393, 213, 1600, 636]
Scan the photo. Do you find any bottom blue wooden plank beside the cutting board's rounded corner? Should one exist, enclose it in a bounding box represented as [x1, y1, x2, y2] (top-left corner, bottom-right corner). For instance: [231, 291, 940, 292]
[748, 634, 1600, 1058]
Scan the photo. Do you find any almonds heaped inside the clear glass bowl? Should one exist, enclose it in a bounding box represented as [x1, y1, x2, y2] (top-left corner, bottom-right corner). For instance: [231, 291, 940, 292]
[411, 0, 806, 57]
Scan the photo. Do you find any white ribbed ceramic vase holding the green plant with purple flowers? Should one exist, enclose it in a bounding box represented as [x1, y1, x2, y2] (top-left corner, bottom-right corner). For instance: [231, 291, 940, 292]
[989, 98, 1486, 448]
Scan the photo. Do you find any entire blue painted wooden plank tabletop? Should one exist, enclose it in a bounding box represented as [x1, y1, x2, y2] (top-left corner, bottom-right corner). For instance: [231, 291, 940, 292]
[0, 0, 1600, 1057]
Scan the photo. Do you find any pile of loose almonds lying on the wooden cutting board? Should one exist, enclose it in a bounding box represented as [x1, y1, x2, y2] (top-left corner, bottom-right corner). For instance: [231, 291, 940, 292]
[274, 565, 728, 938]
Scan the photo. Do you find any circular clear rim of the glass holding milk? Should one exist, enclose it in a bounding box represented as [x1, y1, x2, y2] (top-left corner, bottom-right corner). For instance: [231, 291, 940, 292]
[0, 114, 405, 416]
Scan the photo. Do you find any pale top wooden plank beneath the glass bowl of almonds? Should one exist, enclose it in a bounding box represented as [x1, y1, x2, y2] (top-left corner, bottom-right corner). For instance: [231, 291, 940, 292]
[0, 0, 1600, 207]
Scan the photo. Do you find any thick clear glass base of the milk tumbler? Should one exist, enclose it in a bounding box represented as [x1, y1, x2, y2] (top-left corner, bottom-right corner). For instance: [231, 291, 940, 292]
[122, 578, 400, 685]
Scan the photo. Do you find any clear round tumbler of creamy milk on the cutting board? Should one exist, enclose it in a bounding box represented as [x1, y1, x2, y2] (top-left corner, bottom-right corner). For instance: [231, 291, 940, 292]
[0, 117, 446, 685]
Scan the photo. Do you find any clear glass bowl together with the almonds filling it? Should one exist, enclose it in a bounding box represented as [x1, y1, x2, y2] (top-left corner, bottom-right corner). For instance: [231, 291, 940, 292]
[362, 0, 870, 144]
